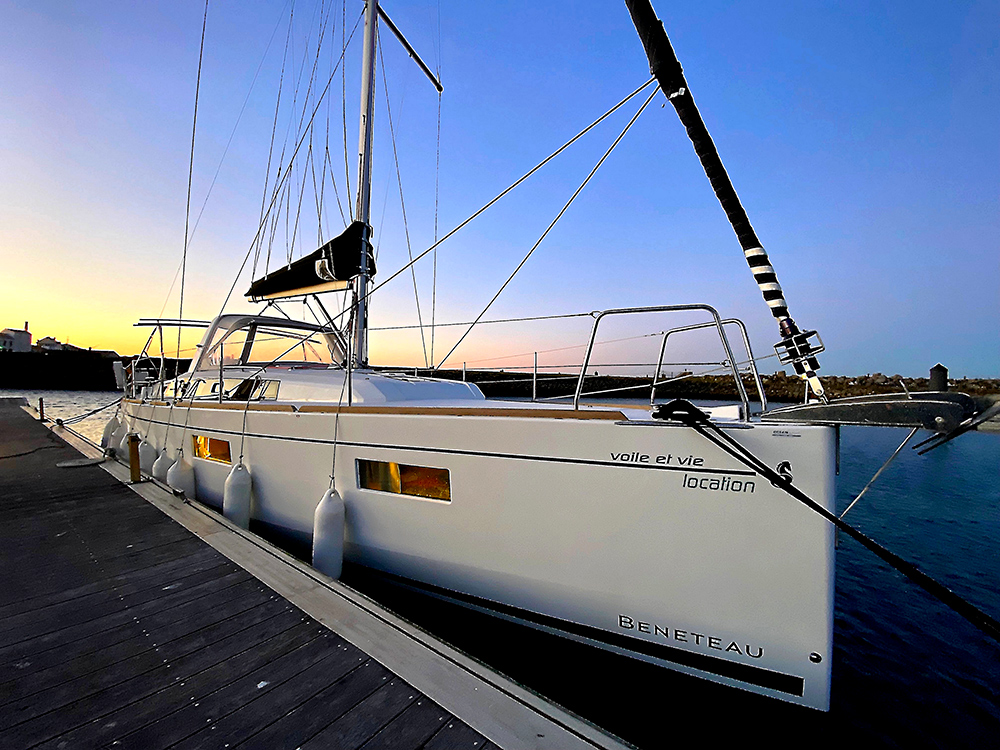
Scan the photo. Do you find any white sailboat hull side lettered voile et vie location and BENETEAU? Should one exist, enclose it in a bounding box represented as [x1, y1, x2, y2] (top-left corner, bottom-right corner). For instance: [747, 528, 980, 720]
[126, 382, 836, 710]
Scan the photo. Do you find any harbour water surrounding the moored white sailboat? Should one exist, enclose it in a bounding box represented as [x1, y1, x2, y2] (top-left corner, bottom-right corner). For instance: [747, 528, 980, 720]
[0, 390, 1000, 748]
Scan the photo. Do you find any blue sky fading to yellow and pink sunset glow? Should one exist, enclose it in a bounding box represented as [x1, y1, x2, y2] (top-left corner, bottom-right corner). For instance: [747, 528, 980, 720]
[0, 0, 1000, 377]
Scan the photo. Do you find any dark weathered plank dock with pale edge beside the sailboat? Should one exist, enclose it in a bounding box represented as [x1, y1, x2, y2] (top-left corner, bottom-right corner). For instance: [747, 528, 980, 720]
[0, 401, 625, 750]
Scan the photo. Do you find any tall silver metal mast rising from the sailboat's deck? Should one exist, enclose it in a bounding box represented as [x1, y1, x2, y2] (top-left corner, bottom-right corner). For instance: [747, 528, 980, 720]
[354, 0, 378, 367]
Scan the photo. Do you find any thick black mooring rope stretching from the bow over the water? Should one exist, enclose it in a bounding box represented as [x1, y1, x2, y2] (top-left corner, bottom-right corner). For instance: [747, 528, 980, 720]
[656, 399, 1000, 642]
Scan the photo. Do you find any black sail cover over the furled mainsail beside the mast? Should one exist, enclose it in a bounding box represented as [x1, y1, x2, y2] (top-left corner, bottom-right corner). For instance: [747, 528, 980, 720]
[246, 221, 375, 302]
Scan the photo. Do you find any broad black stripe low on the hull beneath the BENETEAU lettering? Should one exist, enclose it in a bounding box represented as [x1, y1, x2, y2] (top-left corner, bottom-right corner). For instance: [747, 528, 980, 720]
[365, 567, 805, 698]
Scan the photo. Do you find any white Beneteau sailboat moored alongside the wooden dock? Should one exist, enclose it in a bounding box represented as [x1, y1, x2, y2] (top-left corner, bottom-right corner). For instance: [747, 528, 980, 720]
[112, 0, 992, 710]
